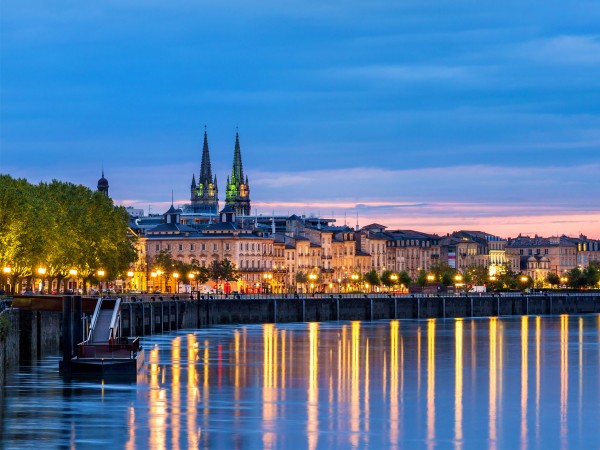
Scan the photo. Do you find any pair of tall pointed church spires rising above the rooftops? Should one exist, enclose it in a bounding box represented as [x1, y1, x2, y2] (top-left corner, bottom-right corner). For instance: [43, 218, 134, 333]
[191, 127, 250, 216]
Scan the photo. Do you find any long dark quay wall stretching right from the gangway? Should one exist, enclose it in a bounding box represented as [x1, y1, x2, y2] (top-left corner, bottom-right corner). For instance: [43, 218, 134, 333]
[121, 294, 600, 336]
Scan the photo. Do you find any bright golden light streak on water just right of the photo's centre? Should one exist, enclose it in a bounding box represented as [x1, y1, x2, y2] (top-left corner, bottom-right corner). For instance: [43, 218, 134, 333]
[306, 322, 319, 450]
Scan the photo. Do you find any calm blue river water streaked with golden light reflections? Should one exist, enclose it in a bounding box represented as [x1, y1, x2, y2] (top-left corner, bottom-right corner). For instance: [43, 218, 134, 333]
[0, 315, 600, 449]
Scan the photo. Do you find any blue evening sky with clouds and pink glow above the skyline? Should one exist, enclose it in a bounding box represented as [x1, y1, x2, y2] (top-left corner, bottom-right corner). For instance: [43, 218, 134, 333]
[0, 0, 600, 239]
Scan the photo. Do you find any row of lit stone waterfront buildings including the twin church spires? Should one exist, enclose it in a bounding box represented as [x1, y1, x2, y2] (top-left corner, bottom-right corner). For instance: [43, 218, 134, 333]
[98, 130, 600, 292]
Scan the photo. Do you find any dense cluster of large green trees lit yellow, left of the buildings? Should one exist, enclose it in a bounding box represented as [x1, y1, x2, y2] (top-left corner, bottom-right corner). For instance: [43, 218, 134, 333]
[0, 175, 137, 293]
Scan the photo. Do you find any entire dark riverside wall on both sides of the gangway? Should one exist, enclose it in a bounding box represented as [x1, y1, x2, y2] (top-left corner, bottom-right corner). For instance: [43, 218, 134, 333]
[0, 293, 600, 386]
